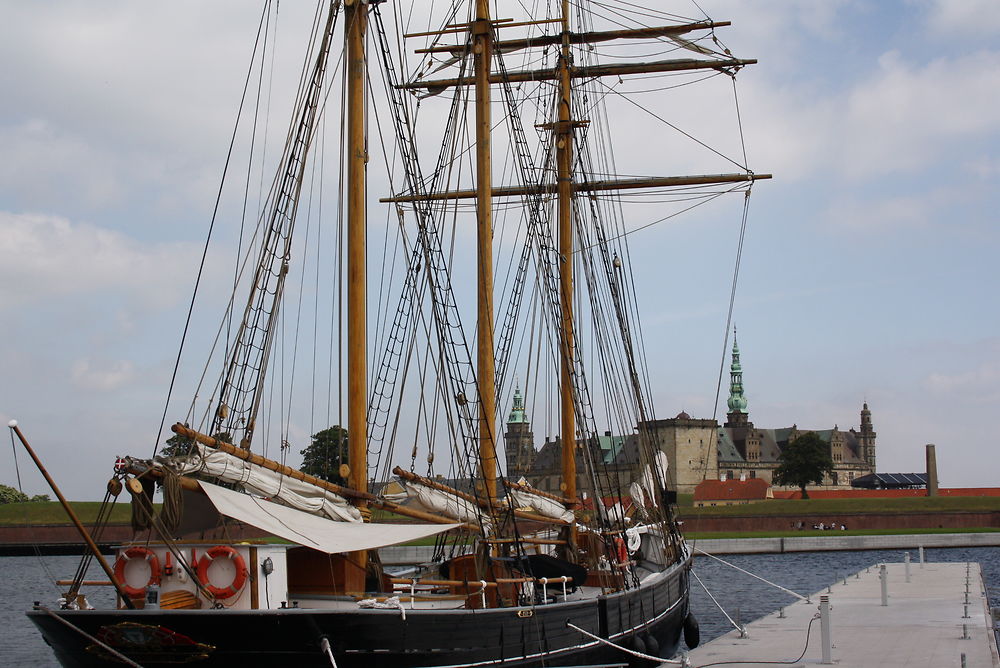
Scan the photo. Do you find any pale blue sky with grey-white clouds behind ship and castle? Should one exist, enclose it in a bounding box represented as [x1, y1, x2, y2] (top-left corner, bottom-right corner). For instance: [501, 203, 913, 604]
[0, 0, 1000, 499]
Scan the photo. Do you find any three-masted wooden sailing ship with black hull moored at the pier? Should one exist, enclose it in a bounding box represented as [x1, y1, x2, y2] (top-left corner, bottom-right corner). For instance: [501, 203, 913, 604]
[23, 0, 767, 668]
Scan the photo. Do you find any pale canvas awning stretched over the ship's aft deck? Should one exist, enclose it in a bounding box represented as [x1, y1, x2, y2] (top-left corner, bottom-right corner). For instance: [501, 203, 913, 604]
[198, 481, 461, 554]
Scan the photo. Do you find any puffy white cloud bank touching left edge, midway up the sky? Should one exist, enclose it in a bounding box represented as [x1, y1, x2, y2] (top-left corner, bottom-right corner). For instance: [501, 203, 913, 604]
[0, 212, 191, 311]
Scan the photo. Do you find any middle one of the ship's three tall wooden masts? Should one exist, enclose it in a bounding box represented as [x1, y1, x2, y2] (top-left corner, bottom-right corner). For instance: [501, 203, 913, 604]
[472, 0, 497, 505]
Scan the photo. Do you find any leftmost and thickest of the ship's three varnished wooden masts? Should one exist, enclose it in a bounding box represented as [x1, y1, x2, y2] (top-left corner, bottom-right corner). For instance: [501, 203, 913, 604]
[344, 0, 368, 568]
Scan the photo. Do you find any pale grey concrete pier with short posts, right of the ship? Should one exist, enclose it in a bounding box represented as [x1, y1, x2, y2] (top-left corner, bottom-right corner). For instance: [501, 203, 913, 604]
[688, 563, 1000, 668]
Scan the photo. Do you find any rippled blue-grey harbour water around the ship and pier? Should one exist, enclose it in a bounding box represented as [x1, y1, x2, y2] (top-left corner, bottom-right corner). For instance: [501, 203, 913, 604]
[0, 547, 1000, 668]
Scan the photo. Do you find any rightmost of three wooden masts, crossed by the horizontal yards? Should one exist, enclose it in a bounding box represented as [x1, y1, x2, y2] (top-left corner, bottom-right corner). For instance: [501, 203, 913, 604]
[555, 0, 576, 499]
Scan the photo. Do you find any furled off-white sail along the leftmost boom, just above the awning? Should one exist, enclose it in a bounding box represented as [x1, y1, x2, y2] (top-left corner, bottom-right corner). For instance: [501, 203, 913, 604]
[170, 444, 362, 523]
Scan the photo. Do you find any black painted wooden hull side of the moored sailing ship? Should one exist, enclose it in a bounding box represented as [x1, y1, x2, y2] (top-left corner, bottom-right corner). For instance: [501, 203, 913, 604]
[28, 564, 688, 668]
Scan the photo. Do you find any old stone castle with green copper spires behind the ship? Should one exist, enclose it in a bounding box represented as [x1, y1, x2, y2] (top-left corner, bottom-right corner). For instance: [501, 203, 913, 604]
[504, 336, 876, 494]
